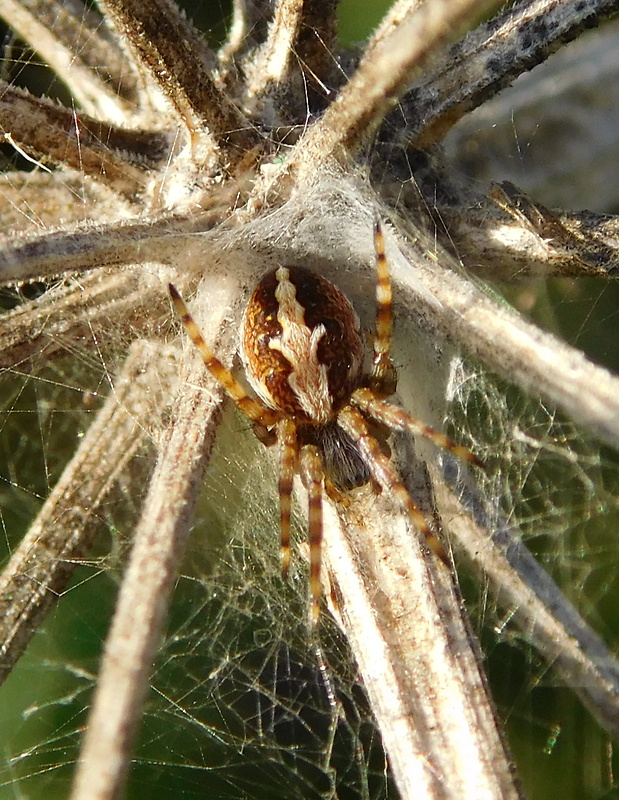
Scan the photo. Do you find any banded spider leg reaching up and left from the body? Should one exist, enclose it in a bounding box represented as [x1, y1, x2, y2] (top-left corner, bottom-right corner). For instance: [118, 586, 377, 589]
[168, 283, 279, 432]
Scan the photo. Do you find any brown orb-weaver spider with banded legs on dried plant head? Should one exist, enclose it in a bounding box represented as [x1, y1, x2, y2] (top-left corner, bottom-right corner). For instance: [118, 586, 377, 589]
[169, 222, 483, 626]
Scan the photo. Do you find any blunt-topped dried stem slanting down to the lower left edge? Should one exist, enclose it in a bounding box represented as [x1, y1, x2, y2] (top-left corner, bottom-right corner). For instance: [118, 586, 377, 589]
[0, 342, 170, 682]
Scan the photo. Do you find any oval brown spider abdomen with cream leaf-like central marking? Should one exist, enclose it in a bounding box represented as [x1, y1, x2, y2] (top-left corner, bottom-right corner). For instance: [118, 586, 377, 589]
[241, 267, 363, 425]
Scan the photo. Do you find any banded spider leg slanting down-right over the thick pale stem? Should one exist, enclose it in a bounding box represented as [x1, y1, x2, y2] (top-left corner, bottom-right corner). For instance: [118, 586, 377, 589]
[337, 408, 450, 567]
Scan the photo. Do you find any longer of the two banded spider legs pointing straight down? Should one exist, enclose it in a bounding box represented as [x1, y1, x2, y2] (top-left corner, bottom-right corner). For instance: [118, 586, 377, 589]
[301, 444, 324, 628]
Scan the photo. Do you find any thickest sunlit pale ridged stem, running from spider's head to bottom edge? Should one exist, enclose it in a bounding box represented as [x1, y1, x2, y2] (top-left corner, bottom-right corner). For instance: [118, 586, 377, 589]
[325, 498, 520, 800]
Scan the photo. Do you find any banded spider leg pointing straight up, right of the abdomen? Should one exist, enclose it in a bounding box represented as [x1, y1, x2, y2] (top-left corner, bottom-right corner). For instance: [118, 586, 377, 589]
[370, 220, 397, 397]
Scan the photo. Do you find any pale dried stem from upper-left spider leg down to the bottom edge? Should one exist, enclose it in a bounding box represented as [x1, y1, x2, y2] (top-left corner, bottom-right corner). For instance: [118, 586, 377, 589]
[71, 370, 219, 800]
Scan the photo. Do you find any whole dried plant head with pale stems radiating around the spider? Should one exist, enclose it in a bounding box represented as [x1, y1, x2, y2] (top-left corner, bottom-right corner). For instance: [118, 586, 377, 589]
[0, 0, 619, 800]
